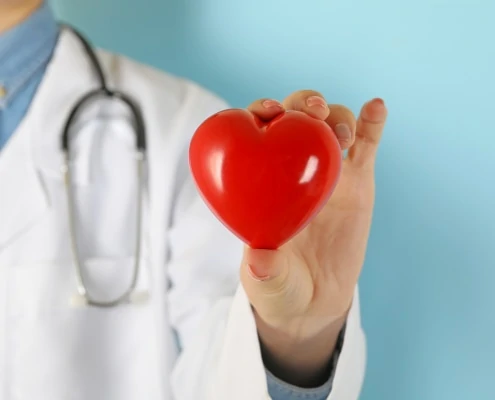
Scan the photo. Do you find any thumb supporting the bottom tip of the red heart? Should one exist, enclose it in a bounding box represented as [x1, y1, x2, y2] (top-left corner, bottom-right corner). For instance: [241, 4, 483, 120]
[241, 247, 312, 320]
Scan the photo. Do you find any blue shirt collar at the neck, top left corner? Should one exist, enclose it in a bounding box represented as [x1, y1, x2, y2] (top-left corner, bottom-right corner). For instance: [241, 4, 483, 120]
[0, 2, 59, 108]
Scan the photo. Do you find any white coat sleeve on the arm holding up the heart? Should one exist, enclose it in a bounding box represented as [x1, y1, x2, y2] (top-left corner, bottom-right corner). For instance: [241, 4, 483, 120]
[167, 83, 365, 400]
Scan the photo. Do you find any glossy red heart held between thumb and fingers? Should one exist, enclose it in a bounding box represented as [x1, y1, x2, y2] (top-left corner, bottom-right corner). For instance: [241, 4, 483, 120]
[189, 109, 342, 249]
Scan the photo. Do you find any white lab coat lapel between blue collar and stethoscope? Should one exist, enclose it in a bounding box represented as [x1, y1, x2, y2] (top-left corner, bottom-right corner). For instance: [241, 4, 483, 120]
[0, 31, 97, 253]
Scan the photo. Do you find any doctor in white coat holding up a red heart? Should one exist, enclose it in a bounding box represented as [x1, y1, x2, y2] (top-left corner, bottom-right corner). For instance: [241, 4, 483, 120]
[0, 0, 386, 400]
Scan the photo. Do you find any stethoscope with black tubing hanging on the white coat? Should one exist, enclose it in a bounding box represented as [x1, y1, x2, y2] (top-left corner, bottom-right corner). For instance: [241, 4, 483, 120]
[60, 25, 146, 307]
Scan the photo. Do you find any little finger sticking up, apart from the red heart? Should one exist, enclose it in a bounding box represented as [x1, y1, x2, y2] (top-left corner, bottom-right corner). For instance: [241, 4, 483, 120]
[348, 99, 387, 168]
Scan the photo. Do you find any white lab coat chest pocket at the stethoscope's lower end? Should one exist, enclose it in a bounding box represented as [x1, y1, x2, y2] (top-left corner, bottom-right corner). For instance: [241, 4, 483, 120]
[6, 258, 159, 400]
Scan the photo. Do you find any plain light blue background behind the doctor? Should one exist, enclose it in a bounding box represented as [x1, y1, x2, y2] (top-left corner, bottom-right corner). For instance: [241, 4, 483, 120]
[54, 0, 495, 400]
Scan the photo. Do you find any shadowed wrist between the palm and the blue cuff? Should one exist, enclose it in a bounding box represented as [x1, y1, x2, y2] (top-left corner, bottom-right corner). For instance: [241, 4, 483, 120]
[254, 312, 347, 387]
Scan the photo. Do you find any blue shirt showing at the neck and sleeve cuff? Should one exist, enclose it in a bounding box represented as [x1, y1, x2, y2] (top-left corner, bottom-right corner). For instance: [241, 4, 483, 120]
[0, 3, 338, 400]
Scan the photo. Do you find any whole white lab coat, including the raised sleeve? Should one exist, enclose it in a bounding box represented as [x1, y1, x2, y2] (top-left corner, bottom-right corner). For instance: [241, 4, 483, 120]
[0, 28, 365, 400]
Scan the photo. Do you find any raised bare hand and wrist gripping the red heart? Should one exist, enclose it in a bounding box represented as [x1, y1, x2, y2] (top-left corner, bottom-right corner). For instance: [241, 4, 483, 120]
[241, 90, 387, 386]
